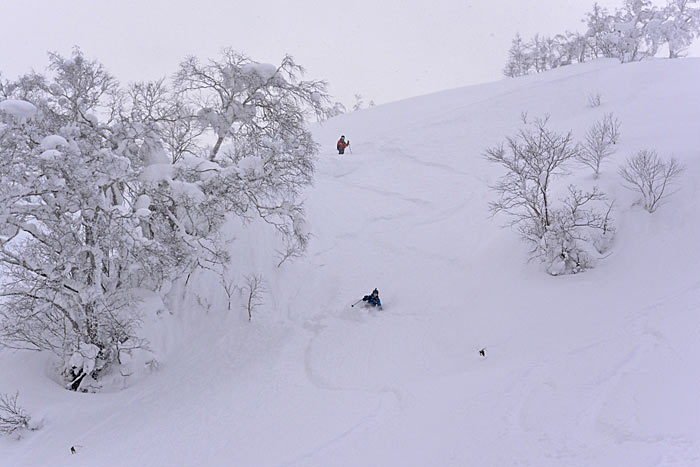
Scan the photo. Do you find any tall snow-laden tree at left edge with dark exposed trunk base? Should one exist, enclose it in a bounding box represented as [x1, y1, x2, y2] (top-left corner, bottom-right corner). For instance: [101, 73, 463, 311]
[0, 50, 158, 388]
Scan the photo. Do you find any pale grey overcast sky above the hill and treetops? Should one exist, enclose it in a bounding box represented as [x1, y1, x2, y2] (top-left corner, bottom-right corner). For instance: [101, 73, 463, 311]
[0, 0, 698, 105]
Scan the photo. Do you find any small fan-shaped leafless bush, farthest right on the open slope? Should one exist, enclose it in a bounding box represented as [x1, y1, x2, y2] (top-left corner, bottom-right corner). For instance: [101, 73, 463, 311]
[620, 149, 684, 212]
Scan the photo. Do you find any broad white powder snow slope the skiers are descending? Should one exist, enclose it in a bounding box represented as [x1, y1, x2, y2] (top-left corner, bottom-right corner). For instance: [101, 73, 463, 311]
[0, 59, 700, 466]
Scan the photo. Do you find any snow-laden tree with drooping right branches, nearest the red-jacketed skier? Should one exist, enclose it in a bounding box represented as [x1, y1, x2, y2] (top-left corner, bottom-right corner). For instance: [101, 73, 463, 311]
[163, 49, 328, 266]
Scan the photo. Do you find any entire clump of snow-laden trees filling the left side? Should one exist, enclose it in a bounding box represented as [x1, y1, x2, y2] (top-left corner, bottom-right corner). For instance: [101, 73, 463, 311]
[0, 49, 327, 389]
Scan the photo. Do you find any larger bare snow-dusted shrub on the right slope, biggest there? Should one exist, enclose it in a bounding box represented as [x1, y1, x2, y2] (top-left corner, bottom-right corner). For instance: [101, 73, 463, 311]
[485, 119, 612, 275]
